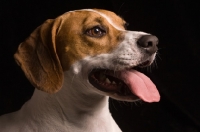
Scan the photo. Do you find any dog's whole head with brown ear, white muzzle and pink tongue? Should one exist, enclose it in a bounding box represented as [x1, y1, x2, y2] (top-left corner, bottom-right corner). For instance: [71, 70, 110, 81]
[15, 9, 160, 102]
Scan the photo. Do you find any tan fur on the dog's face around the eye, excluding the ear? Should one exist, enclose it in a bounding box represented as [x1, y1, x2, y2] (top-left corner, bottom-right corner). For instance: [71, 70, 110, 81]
[56, 9, 125, 71]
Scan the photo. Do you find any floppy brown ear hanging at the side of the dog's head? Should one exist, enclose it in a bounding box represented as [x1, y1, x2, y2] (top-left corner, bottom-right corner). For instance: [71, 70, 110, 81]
[14, 20, 63, 93]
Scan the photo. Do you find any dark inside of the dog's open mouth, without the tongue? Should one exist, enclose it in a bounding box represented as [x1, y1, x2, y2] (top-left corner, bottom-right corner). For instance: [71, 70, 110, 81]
[88, 61, 151, 102]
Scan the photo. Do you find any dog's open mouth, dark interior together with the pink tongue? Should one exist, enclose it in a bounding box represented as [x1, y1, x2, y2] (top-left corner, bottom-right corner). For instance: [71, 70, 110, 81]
[88, 61, 160, 102]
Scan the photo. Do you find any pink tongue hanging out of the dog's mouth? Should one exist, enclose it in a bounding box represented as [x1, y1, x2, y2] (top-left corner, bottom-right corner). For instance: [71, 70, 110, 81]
[120, 70, 160, 102]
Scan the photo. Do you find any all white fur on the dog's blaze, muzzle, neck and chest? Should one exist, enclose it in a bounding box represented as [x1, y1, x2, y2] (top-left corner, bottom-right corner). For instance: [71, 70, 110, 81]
[0, 9, 155, 132]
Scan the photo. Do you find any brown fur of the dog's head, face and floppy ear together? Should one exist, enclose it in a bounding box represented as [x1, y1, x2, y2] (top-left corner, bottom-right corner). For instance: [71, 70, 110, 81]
[15, 10, 124, 93]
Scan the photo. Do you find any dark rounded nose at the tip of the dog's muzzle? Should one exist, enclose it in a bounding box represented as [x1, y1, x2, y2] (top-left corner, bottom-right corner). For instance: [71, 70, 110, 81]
[137, 35, 158, 54]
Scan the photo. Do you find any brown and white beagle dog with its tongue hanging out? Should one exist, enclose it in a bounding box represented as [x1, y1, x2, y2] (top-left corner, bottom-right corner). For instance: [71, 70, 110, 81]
[0, 9, 160, 132]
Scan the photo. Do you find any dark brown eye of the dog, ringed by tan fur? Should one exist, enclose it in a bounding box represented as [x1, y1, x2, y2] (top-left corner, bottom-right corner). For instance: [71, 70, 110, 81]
[86, 26, 106, 38]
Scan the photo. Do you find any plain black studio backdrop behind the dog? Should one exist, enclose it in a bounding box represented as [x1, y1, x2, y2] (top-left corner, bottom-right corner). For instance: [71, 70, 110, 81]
[0, 0, 200, 132]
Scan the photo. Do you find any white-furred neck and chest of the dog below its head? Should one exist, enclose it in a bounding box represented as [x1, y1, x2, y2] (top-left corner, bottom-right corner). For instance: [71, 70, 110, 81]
[0, 71, 121, 132]
